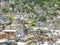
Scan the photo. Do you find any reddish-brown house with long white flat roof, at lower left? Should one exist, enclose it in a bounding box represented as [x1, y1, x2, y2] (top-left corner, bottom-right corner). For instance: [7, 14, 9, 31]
[2, 30, 17, 41]
